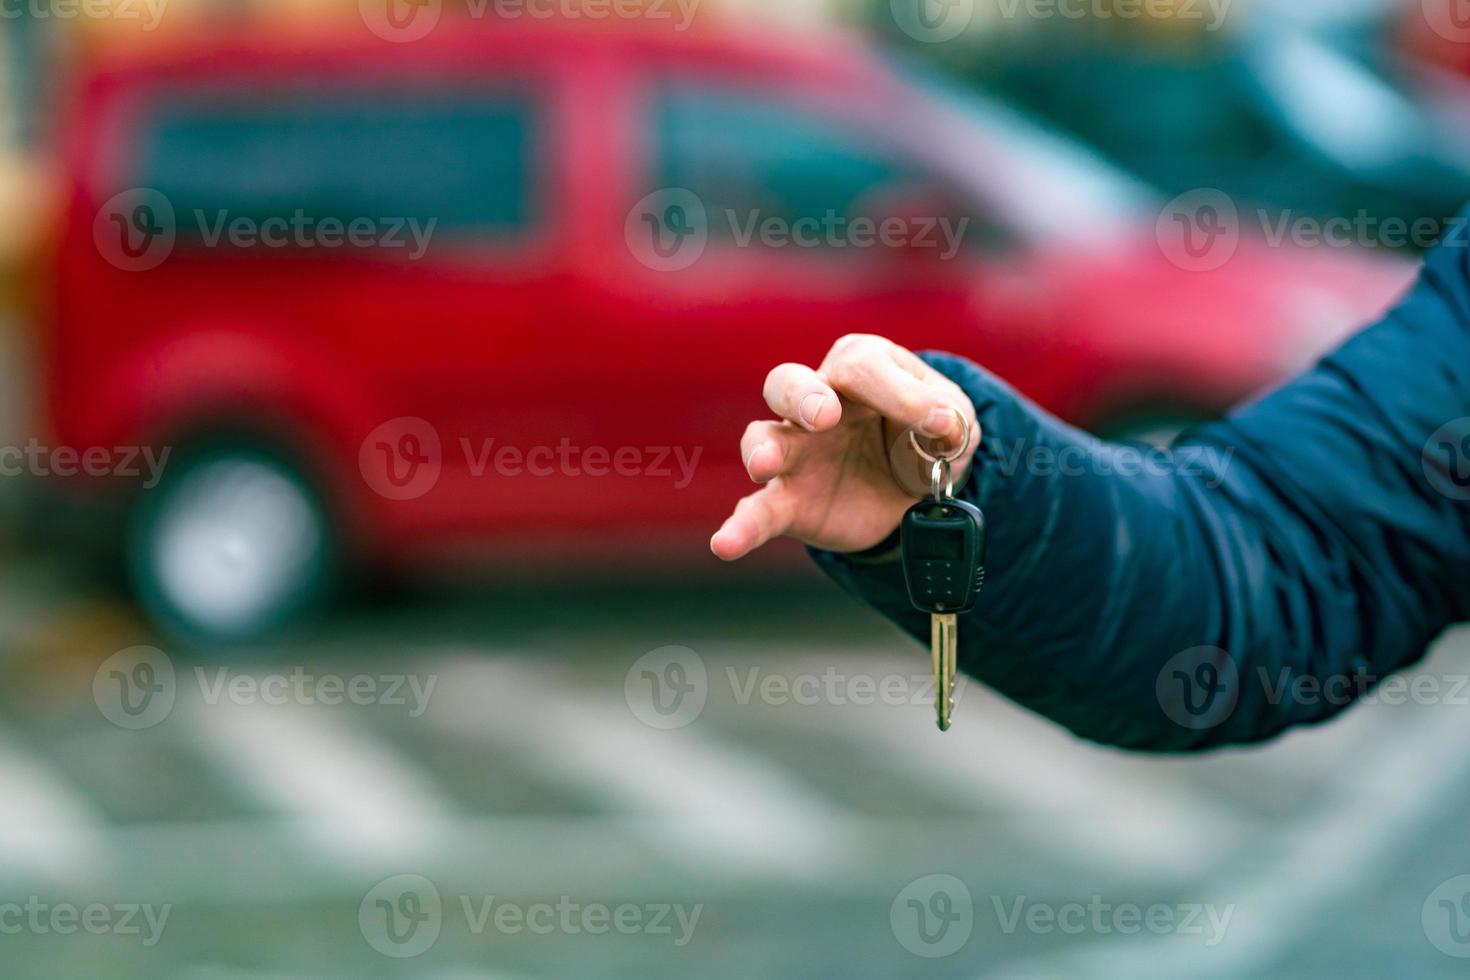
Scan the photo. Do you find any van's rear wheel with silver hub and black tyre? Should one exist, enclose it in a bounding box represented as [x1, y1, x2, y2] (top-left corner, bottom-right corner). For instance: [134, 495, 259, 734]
[126, 448, 335, 646]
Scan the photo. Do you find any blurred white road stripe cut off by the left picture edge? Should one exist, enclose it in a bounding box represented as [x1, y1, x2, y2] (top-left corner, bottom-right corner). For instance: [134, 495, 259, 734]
[0, 731, 109, 882]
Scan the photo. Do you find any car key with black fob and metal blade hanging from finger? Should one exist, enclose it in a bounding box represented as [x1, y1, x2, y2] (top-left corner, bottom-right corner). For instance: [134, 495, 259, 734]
[900, 416, 985, 732]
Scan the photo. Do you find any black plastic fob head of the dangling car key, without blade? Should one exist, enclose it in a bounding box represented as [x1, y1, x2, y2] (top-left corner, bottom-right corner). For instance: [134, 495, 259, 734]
[900, 498, 985, 613]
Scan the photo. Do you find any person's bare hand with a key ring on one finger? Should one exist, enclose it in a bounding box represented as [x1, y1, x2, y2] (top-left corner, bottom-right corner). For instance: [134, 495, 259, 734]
[710, 334, 980, 561]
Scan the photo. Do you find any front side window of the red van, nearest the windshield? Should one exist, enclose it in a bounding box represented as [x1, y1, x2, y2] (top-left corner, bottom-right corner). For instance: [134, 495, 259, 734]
[653, 85, 913, 235]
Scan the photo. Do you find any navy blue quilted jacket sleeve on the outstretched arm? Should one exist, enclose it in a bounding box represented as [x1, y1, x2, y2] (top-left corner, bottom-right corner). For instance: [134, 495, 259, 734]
[814, 235, 1470, 752]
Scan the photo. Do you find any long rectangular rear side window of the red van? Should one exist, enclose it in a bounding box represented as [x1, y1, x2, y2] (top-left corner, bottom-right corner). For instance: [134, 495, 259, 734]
[132, 90, 542, 241]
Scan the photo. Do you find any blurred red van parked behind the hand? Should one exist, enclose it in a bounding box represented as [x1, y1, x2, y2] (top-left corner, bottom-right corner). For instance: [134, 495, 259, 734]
[47, 25, 1408, 641]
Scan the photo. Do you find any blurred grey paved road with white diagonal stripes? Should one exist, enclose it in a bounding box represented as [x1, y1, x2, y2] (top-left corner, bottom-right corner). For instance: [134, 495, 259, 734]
[0, 554, 1470, 980]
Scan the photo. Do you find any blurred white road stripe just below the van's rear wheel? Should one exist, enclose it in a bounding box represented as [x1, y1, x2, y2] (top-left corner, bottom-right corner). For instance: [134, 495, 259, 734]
[186, 683, 451, 867]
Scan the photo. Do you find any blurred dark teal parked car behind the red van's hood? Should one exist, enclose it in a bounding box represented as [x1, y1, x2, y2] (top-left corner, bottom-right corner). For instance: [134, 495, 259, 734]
[969, 24, 1470, 250]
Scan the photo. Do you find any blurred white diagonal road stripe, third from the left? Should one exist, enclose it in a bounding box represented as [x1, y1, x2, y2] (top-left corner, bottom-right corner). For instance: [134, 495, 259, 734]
[426, 655, 858, 882]
